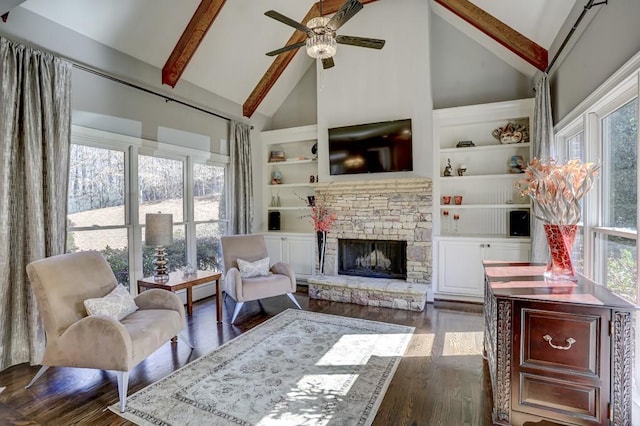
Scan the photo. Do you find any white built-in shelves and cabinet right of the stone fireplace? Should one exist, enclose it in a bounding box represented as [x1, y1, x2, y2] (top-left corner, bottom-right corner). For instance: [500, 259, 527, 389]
[433, 99, 533, 302]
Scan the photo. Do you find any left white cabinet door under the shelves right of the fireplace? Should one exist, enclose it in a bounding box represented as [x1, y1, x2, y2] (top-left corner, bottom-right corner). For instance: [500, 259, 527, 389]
[438, 241, 484, 297]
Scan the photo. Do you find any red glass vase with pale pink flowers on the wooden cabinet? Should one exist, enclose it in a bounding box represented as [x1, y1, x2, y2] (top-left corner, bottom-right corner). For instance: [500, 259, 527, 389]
[515, 158, 599, 281]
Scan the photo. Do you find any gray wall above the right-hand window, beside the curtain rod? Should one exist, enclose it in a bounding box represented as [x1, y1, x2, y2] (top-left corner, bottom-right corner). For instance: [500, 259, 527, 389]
[550, 0, 640, 123]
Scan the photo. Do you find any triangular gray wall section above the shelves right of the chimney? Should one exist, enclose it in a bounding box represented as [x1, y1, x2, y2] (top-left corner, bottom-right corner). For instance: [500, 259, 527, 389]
[430, 12, 534, 109]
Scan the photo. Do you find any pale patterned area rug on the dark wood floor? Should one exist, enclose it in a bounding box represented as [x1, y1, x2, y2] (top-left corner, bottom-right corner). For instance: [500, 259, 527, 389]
[109, 309, 414, 426]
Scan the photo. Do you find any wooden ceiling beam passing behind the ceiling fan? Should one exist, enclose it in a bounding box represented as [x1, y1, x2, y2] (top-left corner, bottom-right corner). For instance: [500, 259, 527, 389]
[242, 0, 376, 117]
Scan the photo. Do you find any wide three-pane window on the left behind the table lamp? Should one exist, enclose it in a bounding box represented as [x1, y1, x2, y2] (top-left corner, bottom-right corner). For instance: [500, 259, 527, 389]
[67, 127, 228, 287]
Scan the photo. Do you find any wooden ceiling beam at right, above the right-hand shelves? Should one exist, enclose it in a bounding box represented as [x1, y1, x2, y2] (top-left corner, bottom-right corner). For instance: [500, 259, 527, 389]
[435, 0, 548, 71]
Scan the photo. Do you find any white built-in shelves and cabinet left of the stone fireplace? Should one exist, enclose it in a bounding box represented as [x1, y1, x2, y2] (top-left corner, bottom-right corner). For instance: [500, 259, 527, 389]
[261, 125, 318, 279]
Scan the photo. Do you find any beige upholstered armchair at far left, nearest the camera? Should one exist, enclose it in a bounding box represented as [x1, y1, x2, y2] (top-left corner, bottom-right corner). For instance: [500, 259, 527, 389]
[27, 251, 191, 412]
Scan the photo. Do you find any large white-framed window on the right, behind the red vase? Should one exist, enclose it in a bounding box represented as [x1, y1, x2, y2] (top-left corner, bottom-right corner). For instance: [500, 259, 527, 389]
[556, 60, 640, 416]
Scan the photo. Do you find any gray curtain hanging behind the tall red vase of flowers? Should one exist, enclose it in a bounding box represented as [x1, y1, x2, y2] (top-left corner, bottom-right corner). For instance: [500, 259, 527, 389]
[531, 73, 553, 262]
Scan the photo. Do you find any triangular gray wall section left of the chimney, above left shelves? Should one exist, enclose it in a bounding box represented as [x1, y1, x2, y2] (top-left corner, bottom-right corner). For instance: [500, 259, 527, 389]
[271, 62, 318, 129]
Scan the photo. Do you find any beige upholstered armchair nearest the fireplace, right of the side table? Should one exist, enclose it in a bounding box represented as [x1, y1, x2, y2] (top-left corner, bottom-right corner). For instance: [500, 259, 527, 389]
[220, 234, 302, 324]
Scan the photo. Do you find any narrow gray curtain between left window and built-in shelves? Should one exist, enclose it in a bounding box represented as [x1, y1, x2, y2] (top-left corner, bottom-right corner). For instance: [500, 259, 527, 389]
[230, 121, 253, 234]
